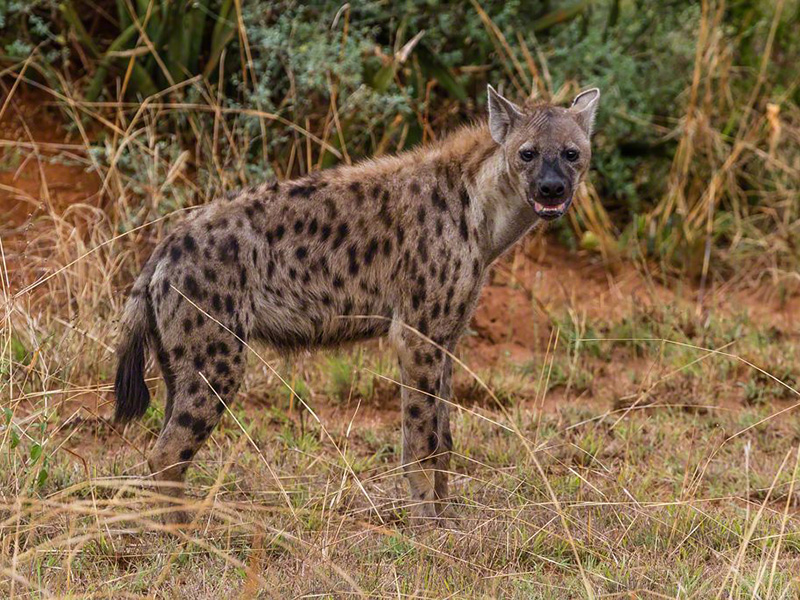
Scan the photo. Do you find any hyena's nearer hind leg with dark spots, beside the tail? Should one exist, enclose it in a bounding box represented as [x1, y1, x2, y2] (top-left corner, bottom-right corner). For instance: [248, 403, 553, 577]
[147, 332, 245, 524]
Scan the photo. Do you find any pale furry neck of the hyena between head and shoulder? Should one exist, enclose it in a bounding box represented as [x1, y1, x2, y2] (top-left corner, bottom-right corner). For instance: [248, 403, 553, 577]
[454, 126, 539, 264]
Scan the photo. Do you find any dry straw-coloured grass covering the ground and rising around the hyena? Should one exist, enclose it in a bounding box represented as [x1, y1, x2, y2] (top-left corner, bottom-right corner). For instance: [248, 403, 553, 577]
[0, 4, 800, 598]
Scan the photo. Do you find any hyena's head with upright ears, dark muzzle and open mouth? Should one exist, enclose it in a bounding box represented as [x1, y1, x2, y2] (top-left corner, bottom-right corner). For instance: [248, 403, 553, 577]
[489, 86, 600, 220]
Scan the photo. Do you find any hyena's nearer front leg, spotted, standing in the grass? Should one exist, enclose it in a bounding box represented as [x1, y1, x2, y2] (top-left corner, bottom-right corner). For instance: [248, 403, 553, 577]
[397, 331, 449, 524]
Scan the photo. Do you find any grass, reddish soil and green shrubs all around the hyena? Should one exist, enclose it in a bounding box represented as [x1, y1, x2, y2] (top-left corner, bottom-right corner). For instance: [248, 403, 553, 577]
[0, 0, 800, 598]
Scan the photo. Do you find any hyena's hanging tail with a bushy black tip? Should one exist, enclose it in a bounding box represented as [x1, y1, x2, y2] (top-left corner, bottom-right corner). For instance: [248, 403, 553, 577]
[114, 273, 152, 423]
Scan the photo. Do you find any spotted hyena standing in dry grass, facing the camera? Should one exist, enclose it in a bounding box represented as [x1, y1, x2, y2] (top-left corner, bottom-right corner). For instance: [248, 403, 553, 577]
[115, 87, 600, 520]
